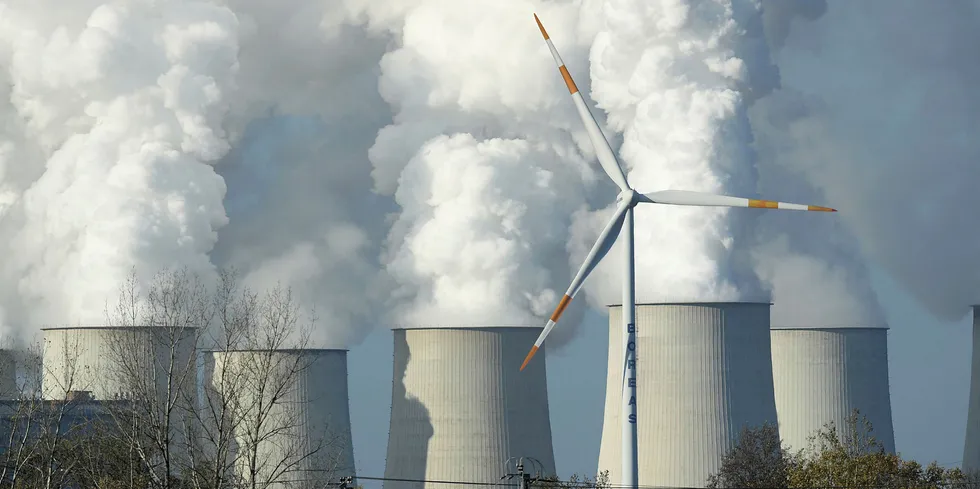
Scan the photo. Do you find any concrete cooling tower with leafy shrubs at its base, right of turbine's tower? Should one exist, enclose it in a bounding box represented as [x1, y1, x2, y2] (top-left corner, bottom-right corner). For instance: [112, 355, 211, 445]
[771, 328, 895, 453]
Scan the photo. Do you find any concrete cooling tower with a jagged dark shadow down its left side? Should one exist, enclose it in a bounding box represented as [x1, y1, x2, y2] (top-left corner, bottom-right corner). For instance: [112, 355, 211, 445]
[384, 327, 555, 489]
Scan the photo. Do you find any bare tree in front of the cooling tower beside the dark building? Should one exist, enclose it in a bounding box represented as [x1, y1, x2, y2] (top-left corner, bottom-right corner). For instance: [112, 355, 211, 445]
[102, 269, 215, 489]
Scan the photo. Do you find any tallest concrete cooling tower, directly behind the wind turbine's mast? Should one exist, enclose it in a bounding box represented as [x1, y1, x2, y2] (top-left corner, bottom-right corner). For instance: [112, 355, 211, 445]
[598, 302, 776, 487]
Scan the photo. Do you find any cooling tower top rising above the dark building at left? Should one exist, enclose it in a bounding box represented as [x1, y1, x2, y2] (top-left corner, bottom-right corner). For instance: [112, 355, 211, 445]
[41, 326, 197, 403]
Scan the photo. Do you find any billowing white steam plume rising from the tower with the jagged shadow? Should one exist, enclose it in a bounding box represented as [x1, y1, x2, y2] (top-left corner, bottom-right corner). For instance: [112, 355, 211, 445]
[352, 0, 595, 338]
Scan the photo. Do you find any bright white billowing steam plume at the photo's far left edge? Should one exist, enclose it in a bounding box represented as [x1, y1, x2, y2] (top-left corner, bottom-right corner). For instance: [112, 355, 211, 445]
[0, 1, 238, 324]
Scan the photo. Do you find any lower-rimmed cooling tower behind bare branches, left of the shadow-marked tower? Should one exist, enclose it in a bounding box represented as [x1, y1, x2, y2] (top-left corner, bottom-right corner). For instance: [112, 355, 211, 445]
[205, 349, 356, 488]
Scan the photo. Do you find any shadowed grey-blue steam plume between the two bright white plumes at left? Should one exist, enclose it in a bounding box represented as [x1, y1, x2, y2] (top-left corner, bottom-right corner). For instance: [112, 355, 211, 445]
[205, 0, 394, 348]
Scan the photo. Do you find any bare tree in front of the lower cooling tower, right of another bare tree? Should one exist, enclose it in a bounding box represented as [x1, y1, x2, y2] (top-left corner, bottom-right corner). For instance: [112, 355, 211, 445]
[205, 287, 353, 489]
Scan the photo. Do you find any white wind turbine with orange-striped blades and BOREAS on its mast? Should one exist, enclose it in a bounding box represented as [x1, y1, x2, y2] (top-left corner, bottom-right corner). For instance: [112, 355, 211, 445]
[521, 14, 837, 489]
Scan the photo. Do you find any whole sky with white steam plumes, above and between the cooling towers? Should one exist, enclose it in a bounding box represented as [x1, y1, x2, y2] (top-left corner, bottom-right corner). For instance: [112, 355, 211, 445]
[0, 0, 980, 486]
